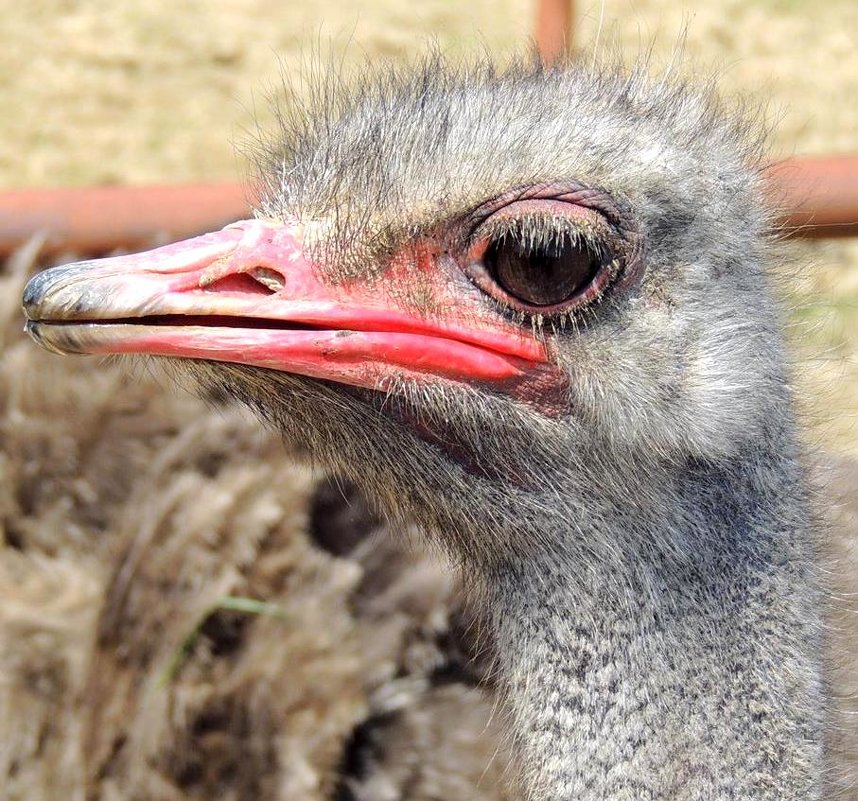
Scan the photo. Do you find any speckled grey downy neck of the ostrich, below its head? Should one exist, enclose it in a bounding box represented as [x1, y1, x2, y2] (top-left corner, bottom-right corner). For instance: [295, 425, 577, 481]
[482, 456, 822, 801]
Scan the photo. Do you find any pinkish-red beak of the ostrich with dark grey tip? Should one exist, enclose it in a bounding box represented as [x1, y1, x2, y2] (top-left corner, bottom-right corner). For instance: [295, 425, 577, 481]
[24, 220, 553, 389]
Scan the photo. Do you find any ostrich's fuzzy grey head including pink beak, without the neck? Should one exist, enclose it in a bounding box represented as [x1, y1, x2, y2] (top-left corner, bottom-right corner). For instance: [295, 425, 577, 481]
[25, 61, 780, 562]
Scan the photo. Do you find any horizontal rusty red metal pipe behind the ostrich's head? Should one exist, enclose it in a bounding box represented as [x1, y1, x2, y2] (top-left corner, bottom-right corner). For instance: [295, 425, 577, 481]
[0, 156, 858, 256]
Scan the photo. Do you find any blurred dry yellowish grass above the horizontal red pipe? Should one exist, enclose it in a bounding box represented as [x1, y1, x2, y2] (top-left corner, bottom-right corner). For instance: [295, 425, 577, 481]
[5, 0, 858, 180]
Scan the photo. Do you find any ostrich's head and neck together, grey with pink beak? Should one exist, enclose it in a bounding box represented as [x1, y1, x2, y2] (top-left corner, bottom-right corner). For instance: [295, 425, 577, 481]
[24, 59, 823, 801]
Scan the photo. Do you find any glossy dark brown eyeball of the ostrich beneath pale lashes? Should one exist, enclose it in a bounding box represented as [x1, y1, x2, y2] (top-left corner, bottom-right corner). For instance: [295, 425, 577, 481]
[484, 236, 600, 306]
